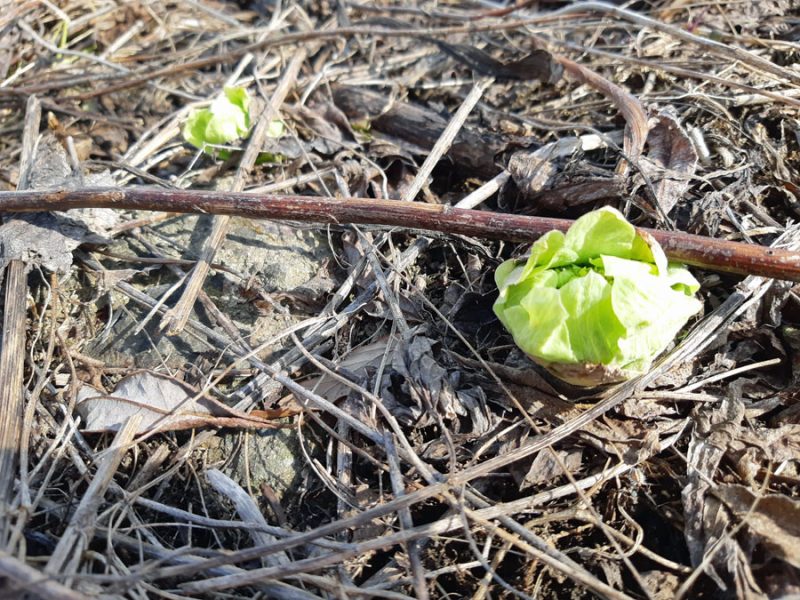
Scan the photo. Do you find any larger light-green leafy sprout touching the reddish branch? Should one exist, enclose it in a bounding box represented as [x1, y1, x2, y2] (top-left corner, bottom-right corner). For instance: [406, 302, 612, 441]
[494, 207, 702, 386]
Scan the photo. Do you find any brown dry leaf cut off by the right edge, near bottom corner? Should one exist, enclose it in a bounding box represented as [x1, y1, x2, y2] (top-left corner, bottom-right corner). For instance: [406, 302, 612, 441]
[713, 485, 800, 569]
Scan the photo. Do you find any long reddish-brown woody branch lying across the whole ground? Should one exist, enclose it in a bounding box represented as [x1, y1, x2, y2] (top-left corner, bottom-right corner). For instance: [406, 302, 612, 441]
[0, 187, 800, 281]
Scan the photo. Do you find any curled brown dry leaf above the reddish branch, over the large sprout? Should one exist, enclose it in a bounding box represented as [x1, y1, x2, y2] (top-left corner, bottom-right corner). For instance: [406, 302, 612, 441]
[639, 111, 697, 215]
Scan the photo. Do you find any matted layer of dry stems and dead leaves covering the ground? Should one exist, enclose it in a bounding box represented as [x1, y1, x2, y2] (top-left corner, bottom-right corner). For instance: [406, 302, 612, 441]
[0, 0, 800, 599]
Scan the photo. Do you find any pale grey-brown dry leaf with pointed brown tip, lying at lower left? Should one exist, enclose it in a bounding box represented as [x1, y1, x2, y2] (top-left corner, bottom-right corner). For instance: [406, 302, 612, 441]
[75, 371, 276, 435]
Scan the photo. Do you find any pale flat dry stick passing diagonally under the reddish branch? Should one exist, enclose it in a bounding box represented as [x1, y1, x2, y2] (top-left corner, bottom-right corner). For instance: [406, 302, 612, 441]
[160, 48, 306, 335]
